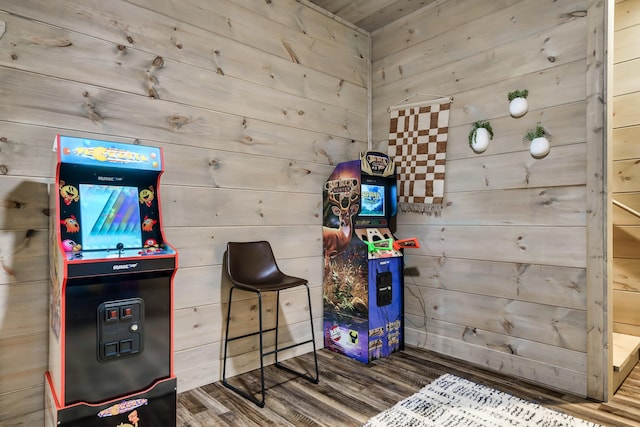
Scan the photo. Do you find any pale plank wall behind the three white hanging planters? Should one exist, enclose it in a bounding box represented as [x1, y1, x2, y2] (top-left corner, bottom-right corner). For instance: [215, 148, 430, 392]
[372, 0, 604, 395]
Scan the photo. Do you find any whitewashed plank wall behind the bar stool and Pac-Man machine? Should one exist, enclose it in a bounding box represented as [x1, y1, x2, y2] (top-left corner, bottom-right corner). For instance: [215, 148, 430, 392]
[0, 0, 369, 425]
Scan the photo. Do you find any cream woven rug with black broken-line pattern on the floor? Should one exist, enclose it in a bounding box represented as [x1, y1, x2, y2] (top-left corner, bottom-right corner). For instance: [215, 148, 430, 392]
[365, 374, 597, 427]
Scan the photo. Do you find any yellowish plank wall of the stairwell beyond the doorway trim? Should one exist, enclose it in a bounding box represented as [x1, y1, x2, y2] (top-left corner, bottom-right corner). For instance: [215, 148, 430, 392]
[612, 0, 640, 336]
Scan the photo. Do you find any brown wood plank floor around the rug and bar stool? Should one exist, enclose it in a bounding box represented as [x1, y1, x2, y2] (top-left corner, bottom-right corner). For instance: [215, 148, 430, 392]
[177, 347, 640, 427]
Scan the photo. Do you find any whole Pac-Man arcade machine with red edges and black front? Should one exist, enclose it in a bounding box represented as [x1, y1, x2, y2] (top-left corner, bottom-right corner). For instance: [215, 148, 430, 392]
[45, 136, 177, 427]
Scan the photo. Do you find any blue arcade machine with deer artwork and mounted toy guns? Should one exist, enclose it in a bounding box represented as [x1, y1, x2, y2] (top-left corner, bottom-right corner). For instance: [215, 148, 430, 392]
[322, 151, 419, 363]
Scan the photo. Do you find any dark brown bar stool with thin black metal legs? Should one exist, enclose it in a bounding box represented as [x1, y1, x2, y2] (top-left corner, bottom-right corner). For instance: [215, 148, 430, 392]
[222, 241, 320, 408]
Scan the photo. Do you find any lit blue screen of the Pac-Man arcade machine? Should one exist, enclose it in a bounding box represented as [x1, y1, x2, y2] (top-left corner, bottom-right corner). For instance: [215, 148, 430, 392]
[79, 184, 142, 250]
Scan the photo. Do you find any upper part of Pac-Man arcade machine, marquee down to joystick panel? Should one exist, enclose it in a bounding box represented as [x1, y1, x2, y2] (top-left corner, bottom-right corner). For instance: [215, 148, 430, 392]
[54, 135, 175, 261]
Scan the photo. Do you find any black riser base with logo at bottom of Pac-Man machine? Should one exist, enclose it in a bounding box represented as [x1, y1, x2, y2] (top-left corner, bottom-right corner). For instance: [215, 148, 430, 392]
[44, 375, 177, 427]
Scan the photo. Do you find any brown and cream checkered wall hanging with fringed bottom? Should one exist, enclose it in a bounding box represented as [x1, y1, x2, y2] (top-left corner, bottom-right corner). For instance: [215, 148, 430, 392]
[388, 97, 452, 215]
